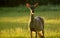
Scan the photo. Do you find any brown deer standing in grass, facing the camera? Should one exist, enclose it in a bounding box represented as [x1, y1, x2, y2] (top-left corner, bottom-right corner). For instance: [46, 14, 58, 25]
[26, 3, 44, 38]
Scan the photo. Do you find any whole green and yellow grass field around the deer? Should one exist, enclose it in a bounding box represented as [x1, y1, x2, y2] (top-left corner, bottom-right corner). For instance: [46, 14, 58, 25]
[0, 6, 60, 38]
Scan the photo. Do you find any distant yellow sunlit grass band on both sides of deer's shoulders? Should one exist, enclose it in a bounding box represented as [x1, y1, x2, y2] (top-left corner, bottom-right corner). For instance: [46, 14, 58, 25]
[0, 16, 60, 24]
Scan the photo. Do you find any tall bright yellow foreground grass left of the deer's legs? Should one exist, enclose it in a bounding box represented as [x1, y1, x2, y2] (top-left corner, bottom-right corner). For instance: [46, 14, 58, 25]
[0, 28, 29, 38]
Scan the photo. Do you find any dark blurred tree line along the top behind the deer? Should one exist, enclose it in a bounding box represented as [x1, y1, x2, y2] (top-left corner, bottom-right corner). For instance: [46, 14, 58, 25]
[0, 0, 60, 6]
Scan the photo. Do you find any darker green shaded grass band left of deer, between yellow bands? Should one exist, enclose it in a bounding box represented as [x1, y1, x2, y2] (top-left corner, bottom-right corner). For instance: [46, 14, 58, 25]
[0, 22, 28, 30]
